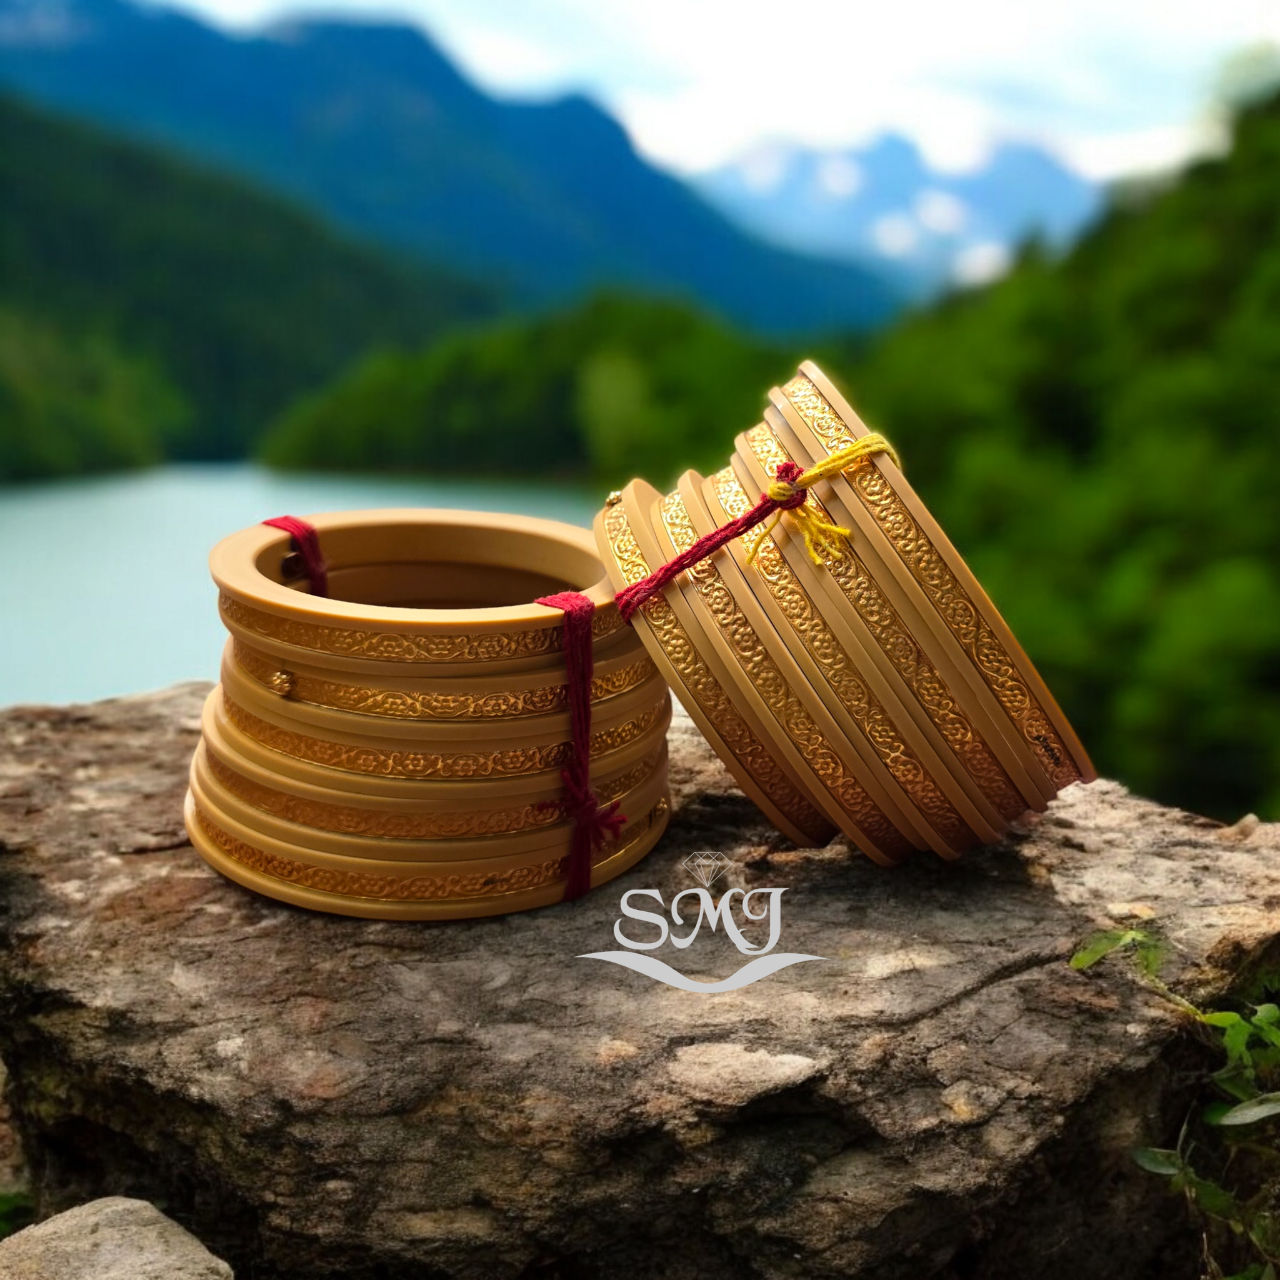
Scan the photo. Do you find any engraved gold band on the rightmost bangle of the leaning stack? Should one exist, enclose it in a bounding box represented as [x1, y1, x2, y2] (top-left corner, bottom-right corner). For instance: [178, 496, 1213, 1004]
[783, 375, 1082, 787]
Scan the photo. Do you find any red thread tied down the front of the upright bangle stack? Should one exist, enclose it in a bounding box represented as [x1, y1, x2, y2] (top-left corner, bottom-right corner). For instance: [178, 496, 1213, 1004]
[536, 591, 626, 902]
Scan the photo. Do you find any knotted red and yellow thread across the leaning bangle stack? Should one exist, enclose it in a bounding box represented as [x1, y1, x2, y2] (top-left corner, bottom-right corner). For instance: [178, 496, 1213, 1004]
[617, 431, 902, 622]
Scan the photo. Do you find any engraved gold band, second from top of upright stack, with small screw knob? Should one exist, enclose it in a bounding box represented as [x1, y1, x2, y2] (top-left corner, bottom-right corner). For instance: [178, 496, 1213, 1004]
[233, 640, 654, 719]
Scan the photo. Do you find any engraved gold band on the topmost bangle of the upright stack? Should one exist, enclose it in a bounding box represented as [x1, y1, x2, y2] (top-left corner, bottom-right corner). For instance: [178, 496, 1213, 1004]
[218, 591, 623, 662]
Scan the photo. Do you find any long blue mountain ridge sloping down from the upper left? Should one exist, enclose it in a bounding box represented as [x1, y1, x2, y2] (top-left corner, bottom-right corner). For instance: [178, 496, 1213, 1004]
[0, 0, 899, 332]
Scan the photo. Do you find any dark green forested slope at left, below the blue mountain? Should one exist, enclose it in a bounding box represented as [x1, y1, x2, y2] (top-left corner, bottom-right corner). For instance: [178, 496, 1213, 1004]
[0, 90, 495, 479]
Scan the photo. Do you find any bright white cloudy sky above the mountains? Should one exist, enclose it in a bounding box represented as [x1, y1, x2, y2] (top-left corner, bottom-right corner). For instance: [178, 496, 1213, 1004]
[170, 0, 1280, 179]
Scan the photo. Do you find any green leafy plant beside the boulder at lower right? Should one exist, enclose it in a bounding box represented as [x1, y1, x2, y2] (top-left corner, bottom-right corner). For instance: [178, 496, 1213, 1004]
[1070, 928, 1280, 1280]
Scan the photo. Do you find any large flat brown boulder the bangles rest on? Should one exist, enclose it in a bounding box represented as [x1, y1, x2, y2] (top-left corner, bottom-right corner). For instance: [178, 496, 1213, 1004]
[0, 686, 1280, 1280]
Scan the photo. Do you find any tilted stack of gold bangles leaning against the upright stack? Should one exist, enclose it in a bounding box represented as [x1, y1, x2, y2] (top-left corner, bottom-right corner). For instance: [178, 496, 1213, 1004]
[595, 362, 1096, 863]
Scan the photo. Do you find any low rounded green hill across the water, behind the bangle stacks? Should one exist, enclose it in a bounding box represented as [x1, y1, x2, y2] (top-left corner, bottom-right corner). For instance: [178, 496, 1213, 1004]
[262, 296, 796, 484]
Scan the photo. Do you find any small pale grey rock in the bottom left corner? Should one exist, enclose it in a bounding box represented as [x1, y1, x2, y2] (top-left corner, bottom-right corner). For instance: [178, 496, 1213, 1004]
[0, 1196, 232, 1280]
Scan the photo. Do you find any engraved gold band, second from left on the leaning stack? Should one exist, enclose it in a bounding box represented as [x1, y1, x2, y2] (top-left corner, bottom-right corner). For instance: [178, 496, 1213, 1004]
[659, 493, 915, 858]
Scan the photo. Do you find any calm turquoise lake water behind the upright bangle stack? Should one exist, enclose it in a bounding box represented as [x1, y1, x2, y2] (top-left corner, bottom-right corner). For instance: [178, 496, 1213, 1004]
[0, 465, 599, 707]
